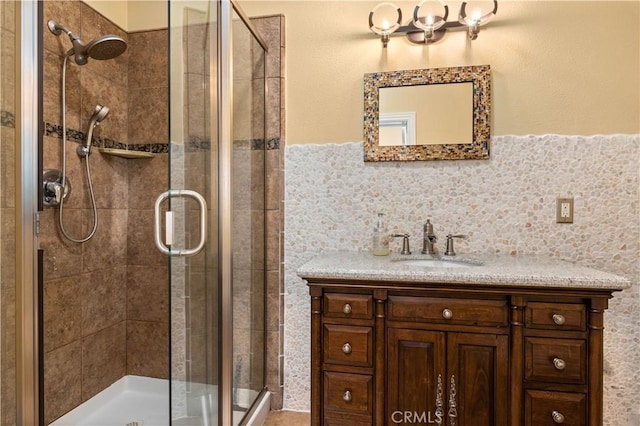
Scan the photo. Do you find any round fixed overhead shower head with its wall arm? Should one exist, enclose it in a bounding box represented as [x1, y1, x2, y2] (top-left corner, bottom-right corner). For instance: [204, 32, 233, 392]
[47, 20, 127, 65]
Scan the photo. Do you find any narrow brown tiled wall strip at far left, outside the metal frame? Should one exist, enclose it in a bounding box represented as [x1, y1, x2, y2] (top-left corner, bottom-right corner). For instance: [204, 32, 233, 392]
[0, 2, 19, 425]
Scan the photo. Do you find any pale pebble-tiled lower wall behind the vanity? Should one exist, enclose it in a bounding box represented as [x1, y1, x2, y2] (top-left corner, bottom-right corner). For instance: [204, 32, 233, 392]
[284, 135, 640, 426]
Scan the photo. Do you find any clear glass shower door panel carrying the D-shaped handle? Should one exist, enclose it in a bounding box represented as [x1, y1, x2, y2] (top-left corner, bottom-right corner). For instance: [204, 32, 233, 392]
[165, 1, 221, 426]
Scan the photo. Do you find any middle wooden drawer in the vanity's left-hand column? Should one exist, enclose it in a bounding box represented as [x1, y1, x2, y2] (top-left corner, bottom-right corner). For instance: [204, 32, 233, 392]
[323, 324, 373, 367]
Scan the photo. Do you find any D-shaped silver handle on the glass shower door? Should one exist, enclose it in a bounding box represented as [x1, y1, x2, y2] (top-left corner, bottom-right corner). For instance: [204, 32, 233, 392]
[154, 189, 207, 256]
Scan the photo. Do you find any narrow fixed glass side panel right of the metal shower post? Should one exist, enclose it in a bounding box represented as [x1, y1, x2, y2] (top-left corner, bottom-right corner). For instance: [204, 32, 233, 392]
[230, 3, 266, 425]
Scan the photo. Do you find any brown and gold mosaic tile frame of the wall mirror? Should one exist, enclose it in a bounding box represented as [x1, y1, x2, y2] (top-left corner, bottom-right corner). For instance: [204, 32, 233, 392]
[364, 65, 491, 161]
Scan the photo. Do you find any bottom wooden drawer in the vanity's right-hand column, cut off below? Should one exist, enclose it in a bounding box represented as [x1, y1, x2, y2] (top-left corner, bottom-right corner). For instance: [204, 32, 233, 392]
[524, 390, 587, 426]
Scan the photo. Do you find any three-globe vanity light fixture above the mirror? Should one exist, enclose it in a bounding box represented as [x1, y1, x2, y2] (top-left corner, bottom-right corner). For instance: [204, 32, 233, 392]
[369, 0, 498, 47]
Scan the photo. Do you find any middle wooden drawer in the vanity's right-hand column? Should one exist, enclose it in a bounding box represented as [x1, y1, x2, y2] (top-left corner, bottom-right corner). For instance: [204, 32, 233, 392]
[524, 337, 587, 384]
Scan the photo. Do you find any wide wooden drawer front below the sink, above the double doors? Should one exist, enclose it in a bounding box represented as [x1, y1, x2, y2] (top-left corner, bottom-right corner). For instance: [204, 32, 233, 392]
[388, 296, 508, 327]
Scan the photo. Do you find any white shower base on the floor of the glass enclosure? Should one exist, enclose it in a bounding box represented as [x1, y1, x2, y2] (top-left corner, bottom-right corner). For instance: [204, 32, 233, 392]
[49, 376, 269, 426]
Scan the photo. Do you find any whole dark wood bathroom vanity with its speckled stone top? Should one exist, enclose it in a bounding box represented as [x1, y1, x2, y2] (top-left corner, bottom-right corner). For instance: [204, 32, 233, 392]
[298, 252, 630, 426]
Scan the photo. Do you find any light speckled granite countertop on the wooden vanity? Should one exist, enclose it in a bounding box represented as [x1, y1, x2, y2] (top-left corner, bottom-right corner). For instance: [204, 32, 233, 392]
[297, 251, 631, 290]
